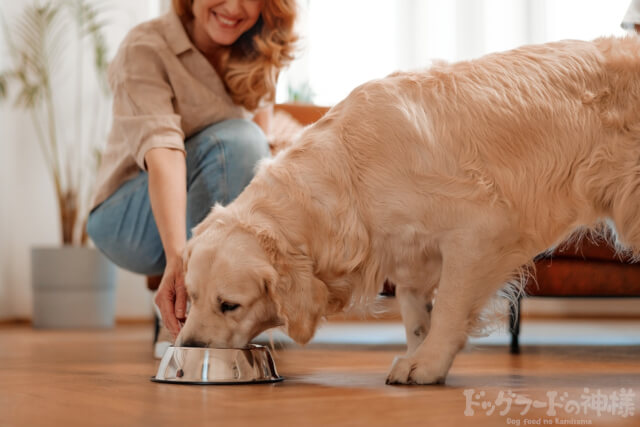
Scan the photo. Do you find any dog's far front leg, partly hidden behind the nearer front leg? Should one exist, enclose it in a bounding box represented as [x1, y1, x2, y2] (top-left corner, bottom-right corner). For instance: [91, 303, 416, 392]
[396, 286, 433, 355]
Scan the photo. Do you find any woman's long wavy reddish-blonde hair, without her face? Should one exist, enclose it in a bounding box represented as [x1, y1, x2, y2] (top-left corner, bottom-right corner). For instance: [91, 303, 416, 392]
[173, 0, 298, 110]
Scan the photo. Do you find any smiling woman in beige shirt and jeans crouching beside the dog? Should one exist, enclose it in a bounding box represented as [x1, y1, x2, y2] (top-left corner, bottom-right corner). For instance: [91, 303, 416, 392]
[88, 0, 296, 356]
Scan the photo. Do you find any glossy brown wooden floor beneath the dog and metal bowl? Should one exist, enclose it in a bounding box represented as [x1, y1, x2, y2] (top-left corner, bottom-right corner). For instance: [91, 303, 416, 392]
[0, 325, 640, 427]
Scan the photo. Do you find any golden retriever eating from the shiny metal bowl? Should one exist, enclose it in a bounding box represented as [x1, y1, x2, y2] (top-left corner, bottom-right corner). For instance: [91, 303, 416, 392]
[177, 38, 640, 384]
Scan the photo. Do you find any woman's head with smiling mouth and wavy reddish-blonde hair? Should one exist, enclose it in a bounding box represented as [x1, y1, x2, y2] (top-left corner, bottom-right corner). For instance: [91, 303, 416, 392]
[173, 0, 296, 109]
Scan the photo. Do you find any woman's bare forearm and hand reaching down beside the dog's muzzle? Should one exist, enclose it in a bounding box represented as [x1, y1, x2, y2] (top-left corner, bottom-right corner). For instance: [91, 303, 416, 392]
[144, 148, 187, 335]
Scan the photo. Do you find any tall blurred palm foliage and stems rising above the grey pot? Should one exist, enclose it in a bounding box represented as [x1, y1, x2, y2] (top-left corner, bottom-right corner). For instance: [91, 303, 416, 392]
[0, 0, 108, 243]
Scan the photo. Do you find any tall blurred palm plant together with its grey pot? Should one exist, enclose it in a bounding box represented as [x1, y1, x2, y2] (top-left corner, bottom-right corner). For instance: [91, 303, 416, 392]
[0, 0, 115, 327]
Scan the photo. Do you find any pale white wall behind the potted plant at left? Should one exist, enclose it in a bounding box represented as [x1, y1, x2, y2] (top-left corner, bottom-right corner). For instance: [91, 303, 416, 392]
[0, 0, 166, 320]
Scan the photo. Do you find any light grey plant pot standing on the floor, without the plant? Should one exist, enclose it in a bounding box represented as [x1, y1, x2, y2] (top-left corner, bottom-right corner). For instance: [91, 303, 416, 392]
[31, 246, 116, 328]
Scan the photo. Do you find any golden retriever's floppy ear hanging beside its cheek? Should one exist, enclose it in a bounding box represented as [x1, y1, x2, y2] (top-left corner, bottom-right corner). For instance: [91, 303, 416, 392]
[267, 260, 329, 344]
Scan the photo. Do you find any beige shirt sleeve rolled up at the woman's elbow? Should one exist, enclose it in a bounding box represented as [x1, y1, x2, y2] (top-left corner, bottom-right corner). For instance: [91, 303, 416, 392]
[109, 43, 185, 170]
